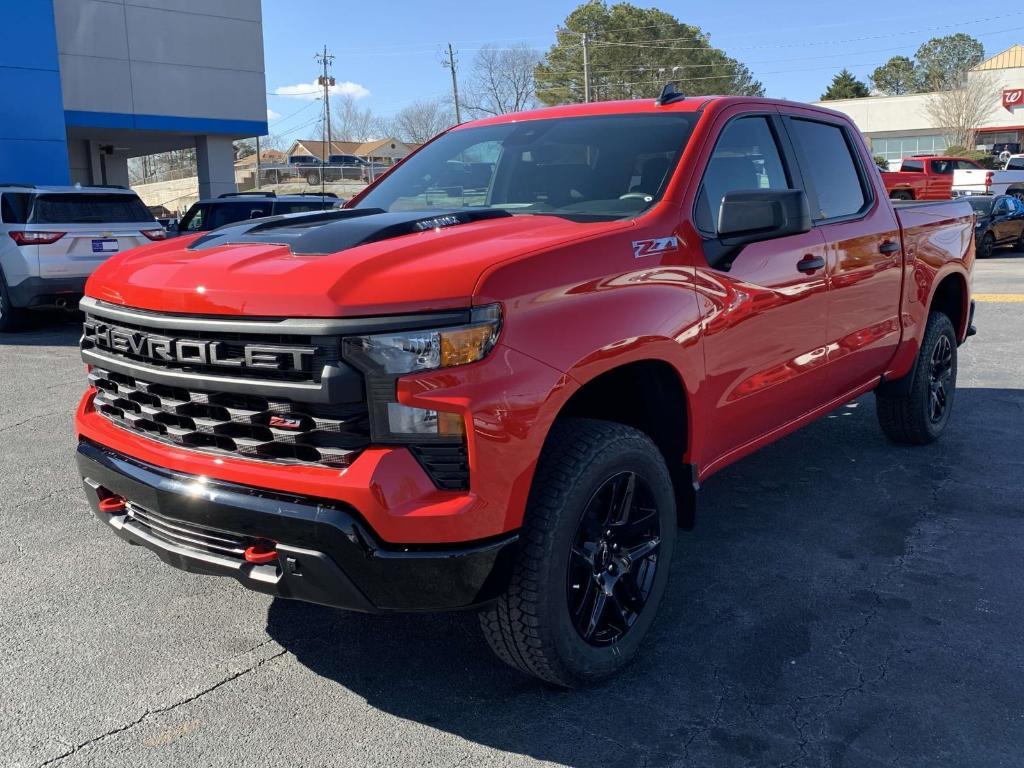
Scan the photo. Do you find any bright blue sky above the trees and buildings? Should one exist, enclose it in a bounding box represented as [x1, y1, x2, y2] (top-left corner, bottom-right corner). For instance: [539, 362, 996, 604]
[263, 0, 1024, 140]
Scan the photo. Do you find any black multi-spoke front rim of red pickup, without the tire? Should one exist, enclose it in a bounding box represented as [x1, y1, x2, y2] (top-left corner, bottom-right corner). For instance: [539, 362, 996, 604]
[566, 472, 662, 647]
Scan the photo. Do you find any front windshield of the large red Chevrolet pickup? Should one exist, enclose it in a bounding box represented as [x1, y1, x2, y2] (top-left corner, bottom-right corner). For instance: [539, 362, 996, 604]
[357, 113, 697, 221]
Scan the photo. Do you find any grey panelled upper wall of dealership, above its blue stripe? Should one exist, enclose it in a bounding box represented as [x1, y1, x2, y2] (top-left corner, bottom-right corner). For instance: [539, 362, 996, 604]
[54, 0, 266, 122]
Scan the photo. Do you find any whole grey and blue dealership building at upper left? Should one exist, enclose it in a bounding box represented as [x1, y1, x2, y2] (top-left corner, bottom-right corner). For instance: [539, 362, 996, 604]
[0, 0, 266, 197]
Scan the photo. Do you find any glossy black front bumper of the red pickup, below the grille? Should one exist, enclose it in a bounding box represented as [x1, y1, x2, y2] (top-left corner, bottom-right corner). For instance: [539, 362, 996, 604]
[78, 440, 518, 613]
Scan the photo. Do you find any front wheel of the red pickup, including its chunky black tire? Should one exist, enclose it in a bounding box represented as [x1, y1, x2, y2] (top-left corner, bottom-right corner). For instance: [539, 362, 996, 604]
[480, 419, 676, 687]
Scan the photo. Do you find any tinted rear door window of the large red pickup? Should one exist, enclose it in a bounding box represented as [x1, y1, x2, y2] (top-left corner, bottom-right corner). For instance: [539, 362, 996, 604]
[788, 118, 868, 221]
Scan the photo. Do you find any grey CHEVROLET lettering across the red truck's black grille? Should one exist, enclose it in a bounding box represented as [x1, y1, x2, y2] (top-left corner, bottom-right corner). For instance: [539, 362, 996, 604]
[82, 317, 316, 371]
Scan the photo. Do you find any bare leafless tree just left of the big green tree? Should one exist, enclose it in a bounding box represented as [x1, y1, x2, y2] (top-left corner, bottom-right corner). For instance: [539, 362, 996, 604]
[461, 45, 541, 117]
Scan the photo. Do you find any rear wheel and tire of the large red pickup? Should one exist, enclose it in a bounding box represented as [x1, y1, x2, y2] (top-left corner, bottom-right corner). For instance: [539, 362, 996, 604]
[874, 312, 956, 445]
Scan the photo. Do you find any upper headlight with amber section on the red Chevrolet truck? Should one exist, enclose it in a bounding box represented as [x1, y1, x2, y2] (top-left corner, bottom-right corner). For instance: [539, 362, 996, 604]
[346, 304, 502, 376]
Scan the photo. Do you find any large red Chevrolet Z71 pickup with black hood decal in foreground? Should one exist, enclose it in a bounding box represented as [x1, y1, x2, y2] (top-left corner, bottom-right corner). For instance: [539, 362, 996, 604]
[77, 91, 974, 686]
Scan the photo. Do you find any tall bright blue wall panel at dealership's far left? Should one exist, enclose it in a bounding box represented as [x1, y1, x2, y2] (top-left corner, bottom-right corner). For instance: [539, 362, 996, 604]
[0, 0, 70, 184]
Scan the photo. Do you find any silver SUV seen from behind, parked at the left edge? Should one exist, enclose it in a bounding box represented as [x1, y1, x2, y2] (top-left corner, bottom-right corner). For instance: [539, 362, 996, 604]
[0, 183, 161, 333]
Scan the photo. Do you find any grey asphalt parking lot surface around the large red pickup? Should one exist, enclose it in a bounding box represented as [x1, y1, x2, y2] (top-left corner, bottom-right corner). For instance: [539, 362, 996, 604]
[0, 254, 1024, 768]
